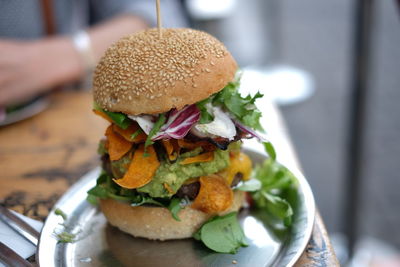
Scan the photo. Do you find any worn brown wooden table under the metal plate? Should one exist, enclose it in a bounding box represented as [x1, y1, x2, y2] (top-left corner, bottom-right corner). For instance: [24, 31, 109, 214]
[0, 91, 339, 266]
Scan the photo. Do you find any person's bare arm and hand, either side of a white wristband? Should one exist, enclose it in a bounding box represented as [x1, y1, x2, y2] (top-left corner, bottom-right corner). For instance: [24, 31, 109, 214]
[0, 15, 147, 108]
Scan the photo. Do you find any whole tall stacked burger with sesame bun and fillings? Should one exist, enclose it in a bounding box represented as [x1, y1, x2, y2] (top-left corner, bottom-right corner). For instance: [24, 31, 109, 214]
[88, 29, 261, 245]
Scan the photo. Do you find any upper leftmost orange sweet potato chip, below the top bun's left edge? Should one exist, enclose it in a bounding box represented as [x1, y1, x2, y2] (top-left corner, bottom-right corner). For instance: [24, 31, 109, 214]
[106, 124, 133, 160]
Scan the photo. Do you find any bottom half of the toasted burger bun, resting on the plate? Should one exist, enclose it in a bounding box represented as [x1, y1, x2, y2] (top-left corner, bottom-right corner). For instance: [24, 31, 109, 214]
[100, 190, 245, 240]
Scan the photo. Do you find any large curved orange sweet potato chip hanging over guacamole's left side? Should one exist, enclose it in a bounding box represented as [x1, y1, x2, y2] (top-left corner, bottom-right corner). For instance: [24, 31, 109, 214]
[114, 144, 160, 189]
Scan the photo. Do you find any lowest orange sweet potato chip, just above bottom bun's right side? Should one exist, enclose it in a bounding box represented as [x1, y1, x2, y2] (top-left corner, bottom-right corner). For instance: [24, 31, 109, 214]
[192, 175, 233, 213]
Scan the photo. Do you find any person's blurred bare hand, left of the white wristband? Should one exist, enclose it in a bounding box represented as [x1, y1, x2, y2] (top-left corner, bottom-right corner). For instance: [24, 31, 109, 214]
[0, 37, 84, 107]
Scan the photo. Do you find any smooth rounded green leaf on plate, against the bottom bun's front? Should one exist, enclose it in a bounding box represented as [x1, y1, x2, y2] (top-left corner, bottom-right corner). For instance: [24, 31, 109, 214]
[193, 212, 248, 254]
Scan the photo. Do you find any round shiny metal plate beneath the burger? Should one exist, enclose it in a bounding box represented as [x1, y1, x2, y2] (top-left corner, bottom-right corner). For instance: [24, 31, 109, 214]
[37, 150, 315, 267]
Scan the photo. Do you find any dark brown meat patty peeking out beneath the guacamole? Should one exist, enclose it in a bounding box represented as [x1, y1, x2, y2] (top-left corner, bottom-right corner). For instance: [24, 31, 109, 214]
[101, 154, 243, 200]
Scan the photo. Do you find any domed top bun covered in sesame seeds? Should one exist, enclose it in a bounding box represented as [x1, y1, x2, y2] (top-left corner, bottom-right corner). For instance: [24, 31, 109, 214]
[93, 29, 237, 115]
